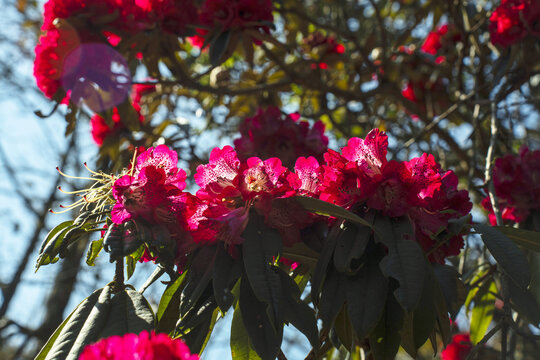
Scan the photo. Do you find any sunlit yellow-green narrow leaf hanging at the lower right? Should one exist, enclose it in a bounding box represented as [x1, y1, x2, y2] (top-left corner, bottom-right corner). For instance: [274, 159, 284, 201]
[471, 281, 497, 345]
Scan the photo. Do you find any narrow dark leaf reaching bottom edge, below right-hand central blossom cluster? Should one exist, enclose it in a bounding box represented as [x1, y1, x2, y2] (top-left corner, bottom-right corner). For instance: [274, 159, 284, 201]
[369, 292, 403, 360]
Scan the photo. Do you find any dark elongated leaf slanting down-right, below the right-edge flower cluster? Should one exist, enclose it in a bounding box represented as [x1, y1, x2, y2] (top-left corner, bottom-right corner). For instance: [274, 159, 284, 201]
[474, 224, 531, 289]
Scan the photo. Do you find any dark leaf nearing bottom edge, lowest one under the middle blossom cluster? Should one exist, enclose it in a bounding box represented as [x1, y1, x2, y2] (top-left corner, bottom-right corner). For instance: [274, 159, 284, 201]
[239, 275, 283, 360]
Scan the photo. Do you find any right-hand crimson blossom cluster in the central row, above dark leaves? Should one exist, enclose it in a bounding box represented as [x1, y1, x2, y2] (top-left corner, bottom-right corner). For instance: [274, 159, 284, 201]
[312, 129, 472, 263]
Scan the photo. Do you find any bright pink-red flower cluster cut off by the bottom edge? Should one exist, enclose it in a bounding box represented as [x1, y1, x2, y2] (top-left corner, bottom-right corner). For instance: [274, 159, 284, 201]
[79, 331, 199, 360]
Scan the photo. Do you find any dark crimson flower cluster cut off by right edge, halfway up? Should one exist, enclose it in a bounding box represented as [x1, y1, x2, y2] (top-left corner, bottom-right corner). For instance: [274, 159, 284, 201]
[482, 146, 540, 225]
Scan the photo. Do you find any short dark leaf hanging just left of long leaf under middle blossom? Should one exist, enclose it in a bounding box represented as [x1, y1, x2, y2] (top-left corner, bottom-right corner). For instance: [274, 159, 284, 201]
[212, 246, 242, 312]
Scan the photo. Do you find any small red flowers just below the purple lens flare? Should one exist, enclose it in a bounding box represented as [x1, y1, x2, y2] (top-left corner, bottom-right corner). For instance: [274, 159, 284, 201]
[90, 84, 156, 146]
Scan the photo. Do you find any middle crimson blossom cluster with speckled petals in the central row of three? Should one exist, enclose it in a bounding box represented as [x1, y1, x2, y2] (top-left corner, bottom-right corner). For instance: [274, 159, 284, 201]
[188, 146, 313, 250]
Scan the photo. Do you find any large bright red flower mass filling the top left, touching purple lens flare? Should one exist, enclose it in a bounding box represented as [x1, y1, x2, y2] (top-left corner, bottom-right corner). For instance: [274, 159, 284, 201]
[34, 0, 197, 99]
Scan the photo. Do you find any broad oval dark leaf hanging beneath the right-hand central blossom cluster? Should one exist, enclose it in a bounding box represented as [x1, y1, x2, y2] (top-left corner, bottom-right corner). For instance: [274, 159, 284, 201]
[346, 260, 388, 339]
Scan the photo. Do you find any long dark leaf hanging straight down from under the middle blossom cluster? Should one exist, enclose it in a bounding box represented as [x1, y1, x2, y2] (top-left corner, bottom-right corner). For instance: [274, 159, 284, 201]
[242, 214, 282, 326]
